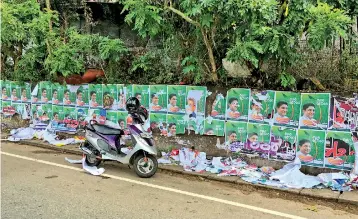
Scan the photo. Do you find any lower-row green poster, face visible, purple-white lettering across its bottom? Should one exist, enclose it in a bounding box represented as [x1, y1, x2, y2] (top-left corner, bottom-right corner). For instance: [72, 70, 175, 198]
[246, 123, 276, 158]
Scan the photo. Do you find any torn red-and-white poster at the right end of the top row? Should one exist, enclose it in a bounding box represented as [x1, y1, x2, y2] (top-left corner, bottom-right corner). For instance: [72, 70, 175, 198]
[328, 96, 358, 131]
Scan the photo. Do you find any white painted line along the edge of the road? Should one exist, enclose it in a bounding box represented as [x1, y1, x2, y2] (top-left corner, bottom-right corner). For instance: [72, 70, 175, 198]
[0, 151, 305, 219]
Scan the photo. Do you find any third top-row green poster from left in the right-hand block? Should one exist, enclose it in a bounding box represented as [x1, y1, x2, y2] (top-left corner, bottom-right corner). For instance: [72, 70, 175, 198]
[273, 91, 301, 127]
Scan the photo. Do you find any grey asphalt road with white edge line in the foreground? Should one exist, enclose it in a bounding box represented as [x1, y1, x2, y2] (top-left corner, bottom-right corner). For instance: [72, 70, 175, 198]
[1, 142, 358, 219]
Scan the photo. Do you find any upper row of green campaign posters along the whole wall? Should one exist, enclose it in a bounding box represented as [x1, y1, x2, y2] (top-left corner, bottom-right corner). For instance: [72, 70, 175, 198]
[1, 81, 358, 131]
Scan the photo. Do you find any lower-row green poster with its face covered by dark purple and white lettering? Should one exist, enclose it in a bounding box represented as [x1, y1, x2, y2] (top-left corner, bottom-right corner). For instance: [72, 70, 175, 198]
[270, 126, 297, 161]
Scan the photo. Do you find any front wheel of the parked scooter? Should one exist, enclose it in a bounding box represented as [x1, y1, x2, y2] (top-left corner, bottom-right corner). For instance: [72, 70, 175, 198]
[133, 154, 158, 178]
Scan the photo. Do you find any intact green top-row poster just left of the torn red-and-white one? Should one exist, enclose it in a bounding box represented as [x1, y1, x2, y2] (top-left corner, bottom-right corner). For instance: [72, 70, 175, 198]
[299, 93, 331, 130]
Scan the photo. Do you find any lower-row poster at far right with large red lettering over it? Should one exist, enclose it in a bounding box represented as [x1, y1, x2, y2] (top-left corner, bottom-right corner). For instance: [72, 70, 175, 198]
[324, 131, 358, 170]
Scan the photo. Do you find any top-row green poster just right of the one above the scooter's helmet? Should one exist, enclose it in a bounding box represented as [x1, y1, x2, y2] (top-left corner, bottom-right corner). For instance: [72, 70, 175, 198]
[149, 85, 168, 113]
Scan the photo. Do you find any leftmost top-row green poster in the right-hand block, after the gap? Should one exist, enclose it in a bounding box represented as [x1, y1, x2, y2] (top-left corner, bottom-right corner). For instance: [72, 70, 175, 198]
[226, 88, 250, 121]
